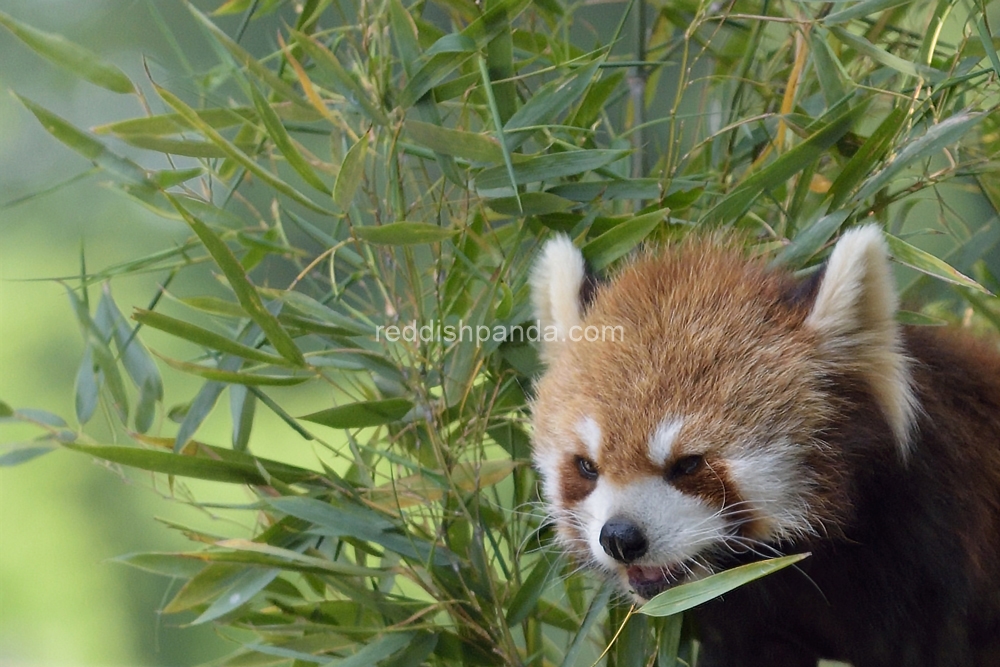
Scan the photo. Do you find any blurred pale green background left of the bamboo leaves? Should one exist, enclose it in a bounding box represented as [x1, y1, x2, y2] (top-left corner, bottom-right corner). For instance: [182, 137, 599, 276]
[0, 0, 273, 667]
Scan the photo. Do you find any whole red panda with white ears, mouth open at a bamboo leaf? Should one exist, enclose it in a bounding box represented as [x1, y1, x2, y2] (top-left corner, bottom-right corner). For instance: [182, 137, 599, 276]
[531, 226, 1000, 667]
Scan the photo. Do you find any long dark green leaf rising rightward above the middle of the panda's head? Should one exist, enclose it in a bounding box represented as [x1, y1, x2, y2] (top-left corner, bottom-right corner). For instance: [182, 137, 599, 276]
[702, 103, 868, 224]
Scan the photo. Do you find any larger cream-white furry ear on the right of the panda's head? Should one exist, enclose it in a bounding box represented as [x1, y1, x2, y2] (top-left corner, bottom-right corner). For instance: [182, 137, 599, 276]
[805, 225, 918, 456]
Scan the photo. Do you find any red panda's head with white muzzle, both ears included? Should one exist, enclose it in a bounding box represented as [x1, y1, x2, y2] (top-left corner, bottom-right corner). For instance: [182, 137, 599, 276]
[533, 228, 912, 600]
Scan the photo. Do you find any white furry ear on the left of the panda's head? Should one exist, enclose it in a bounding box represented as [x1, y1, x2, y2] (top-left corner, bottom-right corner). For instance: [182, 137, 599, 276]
[531, 234, 586, 362]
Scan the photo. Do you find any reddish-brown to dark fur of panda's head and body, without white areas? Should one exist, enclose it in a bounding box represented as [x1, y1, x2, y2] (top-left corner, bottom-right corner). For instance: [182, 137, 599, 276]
[534, 240, 1000, 667]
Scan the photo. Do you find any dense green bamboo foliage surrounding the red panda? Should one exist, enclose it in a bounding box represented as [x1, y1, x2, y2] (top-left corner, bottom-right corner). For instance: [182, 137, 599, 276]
[0, 0, 1000, 667]
